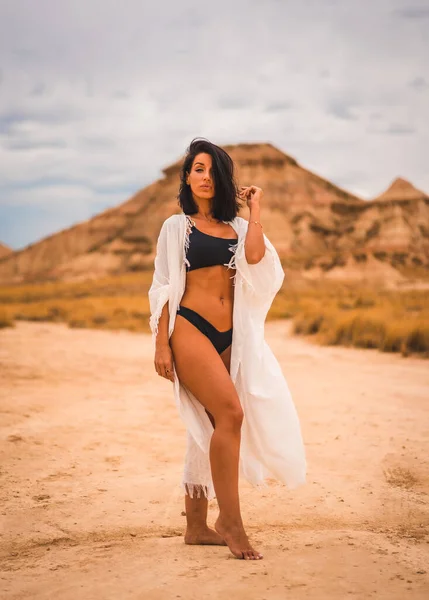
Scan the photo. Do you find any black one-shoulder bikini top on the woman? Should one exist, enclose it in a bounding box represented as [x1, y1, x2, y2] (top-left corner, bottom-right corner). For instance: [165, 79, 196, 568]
[186, 225, 237, 271]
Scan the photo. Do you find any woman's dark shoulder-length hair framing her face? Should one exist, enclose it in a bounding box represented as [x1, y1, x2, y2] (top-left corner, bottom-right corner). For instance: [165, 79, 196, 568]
[177, 138, 241, 221]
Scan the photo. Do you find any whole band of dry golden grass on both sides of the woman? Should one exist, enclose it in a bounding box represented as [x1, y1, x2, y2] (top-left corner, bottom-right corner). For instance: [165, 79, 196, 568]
[0, 271, 429, 356]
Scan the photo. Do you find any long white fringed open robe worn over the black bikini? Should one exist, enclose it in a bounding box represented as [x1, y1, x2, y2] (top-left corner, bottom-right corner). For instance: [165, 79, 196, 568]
[149, 213, 306, 499]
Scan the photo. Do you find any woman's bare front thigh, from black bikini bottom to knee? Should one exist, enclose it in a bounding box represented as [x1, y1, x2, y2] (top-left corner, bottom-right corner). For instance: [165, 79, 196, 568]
[170, 315, 241, 422]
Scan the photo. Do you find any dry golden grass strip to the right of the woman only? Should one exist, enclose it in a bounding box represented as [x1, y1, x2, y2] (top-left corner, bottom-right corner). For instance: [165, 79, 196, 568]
[278, 284, 429, 357]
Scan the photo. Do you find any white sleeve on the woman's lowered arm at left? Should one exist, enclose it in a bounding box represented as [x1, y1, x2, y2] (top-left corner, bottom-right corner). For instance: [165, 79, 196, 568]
[148, 221, 170, 342]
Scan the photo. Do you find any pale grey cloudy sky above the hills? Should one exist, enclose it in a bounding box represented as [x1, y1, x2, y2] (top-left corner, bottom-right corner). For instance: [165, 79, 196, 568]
[0, 0, 429, 248]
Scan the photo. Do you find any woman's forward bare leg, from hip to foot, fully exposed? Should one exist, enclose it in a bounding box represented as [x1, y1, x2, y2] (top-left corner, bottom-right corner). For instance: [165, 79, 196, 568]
[170, 315, 262, 559]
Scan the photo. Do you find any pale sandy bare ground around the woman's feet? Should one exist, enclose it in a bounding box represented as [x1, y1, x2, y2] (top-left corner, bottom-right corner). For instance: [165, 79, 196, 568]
[0, 322, 429, 600]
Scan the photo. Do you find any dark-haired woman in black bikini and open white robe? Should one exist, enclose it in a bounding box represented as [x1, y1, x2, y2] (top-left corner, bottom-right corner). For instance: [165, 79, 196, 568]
[149, 139, 306, 560]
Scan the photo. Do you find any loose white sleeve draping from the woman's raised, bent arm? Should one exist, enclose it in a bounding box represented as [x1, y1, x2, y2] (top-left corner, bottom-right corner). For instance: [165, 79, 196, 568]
[234, 219, 285, 300]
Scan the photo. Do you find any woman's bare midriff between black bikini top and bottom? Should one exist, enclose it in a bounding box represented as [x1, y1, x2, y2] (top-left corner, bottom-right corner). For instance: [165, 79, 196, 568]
[180, 265, 235, 331]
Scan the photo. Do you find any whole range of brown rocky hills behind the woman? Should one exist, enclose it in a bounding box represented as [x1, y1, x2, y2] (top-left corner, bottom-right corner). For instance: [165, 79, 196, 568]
[0, 144, 429, 282]
